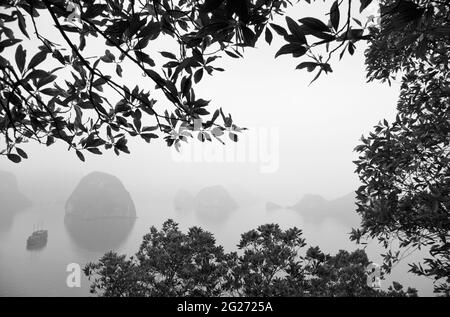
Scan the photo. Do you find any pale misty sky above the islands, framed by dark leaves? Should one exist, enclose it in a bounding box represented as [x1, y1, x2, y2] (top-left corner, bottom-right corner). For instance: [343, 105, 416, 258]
[0, 2, 398, 204]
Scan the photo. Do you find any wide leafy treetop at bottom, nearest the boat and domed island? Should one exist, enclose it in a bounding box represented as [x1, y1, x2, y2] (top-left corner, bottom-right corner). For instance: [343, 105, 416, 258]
[85, 220, 234, 296]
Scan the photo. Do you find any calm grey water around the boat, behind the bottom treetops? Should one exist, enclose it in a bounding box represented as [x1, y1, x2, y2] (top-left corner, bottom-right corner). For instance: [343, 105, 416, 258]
[0, 200, 432, 296]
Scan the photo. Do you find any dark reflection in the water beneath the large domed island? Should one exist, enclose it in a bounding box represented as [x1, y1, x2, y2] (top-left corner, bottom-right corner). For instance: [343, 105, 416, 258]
[64, 217, 136, 252]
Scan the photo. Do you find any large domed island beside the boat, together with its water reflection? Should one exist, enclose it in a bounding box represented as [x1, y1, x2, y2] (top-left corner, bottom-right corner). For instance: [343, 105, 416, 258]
[64, 172, 136, 252]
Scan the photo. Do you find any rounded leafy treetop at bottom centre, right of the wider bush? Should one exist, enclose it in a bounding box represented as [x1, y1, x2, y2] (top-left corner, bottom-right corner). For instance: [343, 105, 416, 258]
[232, 224, 306, 296]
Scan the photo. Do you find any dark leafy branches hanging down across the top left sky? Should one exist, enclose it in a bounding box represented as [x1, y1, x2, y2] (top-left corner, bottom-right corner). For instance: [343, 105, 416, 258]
[0, 0, 380, 162]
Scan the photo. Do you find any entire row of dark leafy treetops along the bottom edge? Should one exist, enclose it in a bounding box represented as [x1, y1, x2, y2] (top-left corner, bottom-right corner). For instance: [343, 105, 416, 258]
[84, 220, 417, 297]
